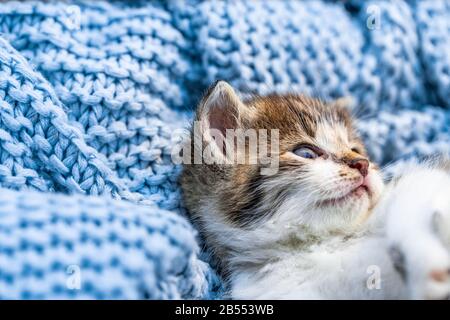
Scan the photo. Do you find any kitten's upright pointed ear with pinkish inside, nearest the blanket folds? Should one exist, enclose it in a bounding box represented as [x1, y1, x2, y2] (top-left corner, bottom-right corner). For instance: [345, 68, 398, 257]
[196, 81, 251, 162]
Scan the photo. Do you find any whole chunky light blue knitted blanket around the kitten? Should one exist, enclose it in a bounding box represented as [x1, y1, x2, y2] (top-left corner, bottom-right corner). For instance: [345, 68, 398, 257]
[0, 0, 450, 299]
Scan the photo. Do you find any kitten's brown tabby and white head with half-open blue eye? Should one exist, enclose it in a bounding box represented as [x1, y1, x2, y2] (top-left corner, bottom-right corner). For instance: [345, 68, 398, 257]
[182, 82, 383, 255]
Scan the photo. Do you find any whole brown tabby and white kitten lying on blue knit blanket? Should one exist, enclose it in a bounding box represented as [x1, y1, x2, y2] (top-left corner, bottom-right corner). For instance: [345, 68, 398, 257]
[181, 81, 450, 299]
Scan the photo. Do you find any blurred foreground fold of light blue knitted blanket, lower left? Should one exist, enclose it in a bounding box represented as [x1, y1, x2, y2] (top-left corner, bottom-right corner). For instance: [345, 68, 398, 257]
[0, 189, 218, 299]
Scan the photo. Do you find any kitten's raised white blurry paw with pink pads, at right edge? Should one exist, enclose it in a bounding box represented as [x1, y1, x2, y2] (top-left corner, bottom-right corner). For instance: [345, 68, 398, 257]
[388, 166, 450, 300]
